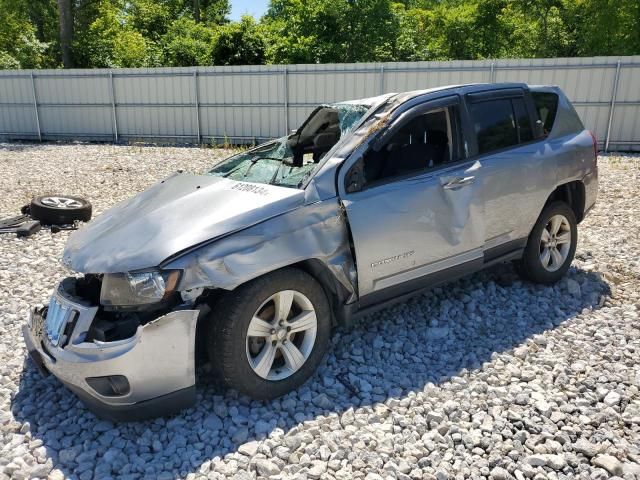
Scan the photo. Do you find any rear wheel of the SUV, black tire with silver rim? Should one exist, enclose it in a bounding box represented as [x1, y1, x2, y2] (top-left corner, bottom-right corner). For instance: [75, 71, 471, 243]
[516, 202, 578, 285]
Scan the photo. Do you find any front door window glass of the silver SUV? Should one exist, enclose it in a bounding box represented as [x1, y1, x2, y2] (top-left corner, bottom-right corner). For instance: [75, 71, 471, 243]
[362, 107, 458, 185]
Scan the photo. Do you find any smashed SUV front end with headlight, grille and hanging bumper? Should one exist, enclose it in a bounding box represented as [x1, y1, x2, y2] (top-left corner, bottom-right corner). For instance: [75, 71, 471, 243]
[23, 270, 205, 421]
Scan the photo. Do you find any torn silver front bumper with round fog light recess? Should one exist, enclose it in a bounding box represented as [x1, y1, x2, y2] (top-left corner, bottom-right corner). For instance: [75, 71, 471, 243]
[22, 284, 199, 421]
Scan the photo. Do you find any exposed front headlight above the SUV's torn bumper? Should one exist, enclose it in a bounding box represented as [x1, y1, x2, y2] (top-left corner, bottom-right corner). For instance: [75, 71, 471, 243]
[100, 270, 180, 307]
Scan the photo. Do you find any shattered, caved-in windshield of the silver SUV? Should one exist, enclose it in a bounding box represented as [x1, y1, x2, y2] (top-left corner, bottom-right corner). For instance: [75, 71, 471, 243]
[208, 103, 369, 188]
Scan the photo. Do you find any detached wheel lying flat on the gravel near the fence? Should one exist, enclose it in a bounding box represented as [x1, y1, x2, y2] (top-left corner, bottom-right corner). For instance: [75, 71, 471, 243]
[29, 195, 91, 225]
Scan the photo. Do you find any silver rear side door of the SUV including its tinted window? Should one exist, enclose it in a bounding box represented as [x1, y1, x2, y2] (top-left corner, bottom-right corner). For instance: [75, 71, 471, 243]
[466, 88, 555, 261]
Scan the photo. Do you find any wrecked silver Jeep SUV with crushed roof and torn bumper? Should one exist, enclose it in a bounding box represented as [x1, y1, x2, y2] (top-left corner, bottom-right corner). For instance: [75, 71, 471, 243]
[23, 84, 597, 420]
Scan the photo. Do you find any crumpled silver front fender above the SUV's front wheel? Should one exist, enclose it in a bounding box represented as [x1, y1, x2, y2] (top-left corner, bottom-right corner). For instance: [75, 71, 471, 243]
[162, 198, 356, 295]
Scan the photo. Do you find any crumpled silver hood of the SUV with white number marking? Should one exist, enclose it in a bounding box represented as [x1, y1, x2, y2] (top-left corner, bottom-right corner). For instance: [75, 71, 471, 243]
[63, 173, 304, 273]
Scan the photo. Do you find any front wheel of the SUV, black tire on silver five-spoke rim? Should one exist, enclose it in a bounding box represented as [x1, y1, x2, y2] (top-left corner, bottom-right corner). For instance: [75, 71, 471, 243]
[207, 268, 331, 400]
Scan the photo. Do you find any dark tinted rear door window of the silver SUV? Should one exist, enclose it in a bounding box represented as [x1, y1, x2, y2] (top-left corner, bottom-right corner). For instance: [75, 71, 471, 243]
[470, 97, 533, 154]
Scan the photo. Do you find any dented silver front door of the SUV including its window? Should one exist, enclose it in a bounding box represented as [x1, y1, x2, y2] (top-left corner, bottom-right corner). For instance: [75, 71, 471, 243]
[338, 95, 484, 307]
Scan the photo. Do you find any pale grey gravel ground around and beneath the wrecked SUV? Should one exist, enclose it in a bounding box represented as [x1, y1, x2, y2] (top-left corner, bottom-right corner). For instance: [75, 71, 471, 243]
[0, 144, 640, 480]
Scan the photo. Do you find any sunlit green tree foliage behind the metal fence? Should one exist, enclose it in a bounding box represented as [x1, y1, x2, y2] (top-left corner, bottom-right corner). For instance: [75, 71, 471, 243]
[0, 0, 640, 68]
